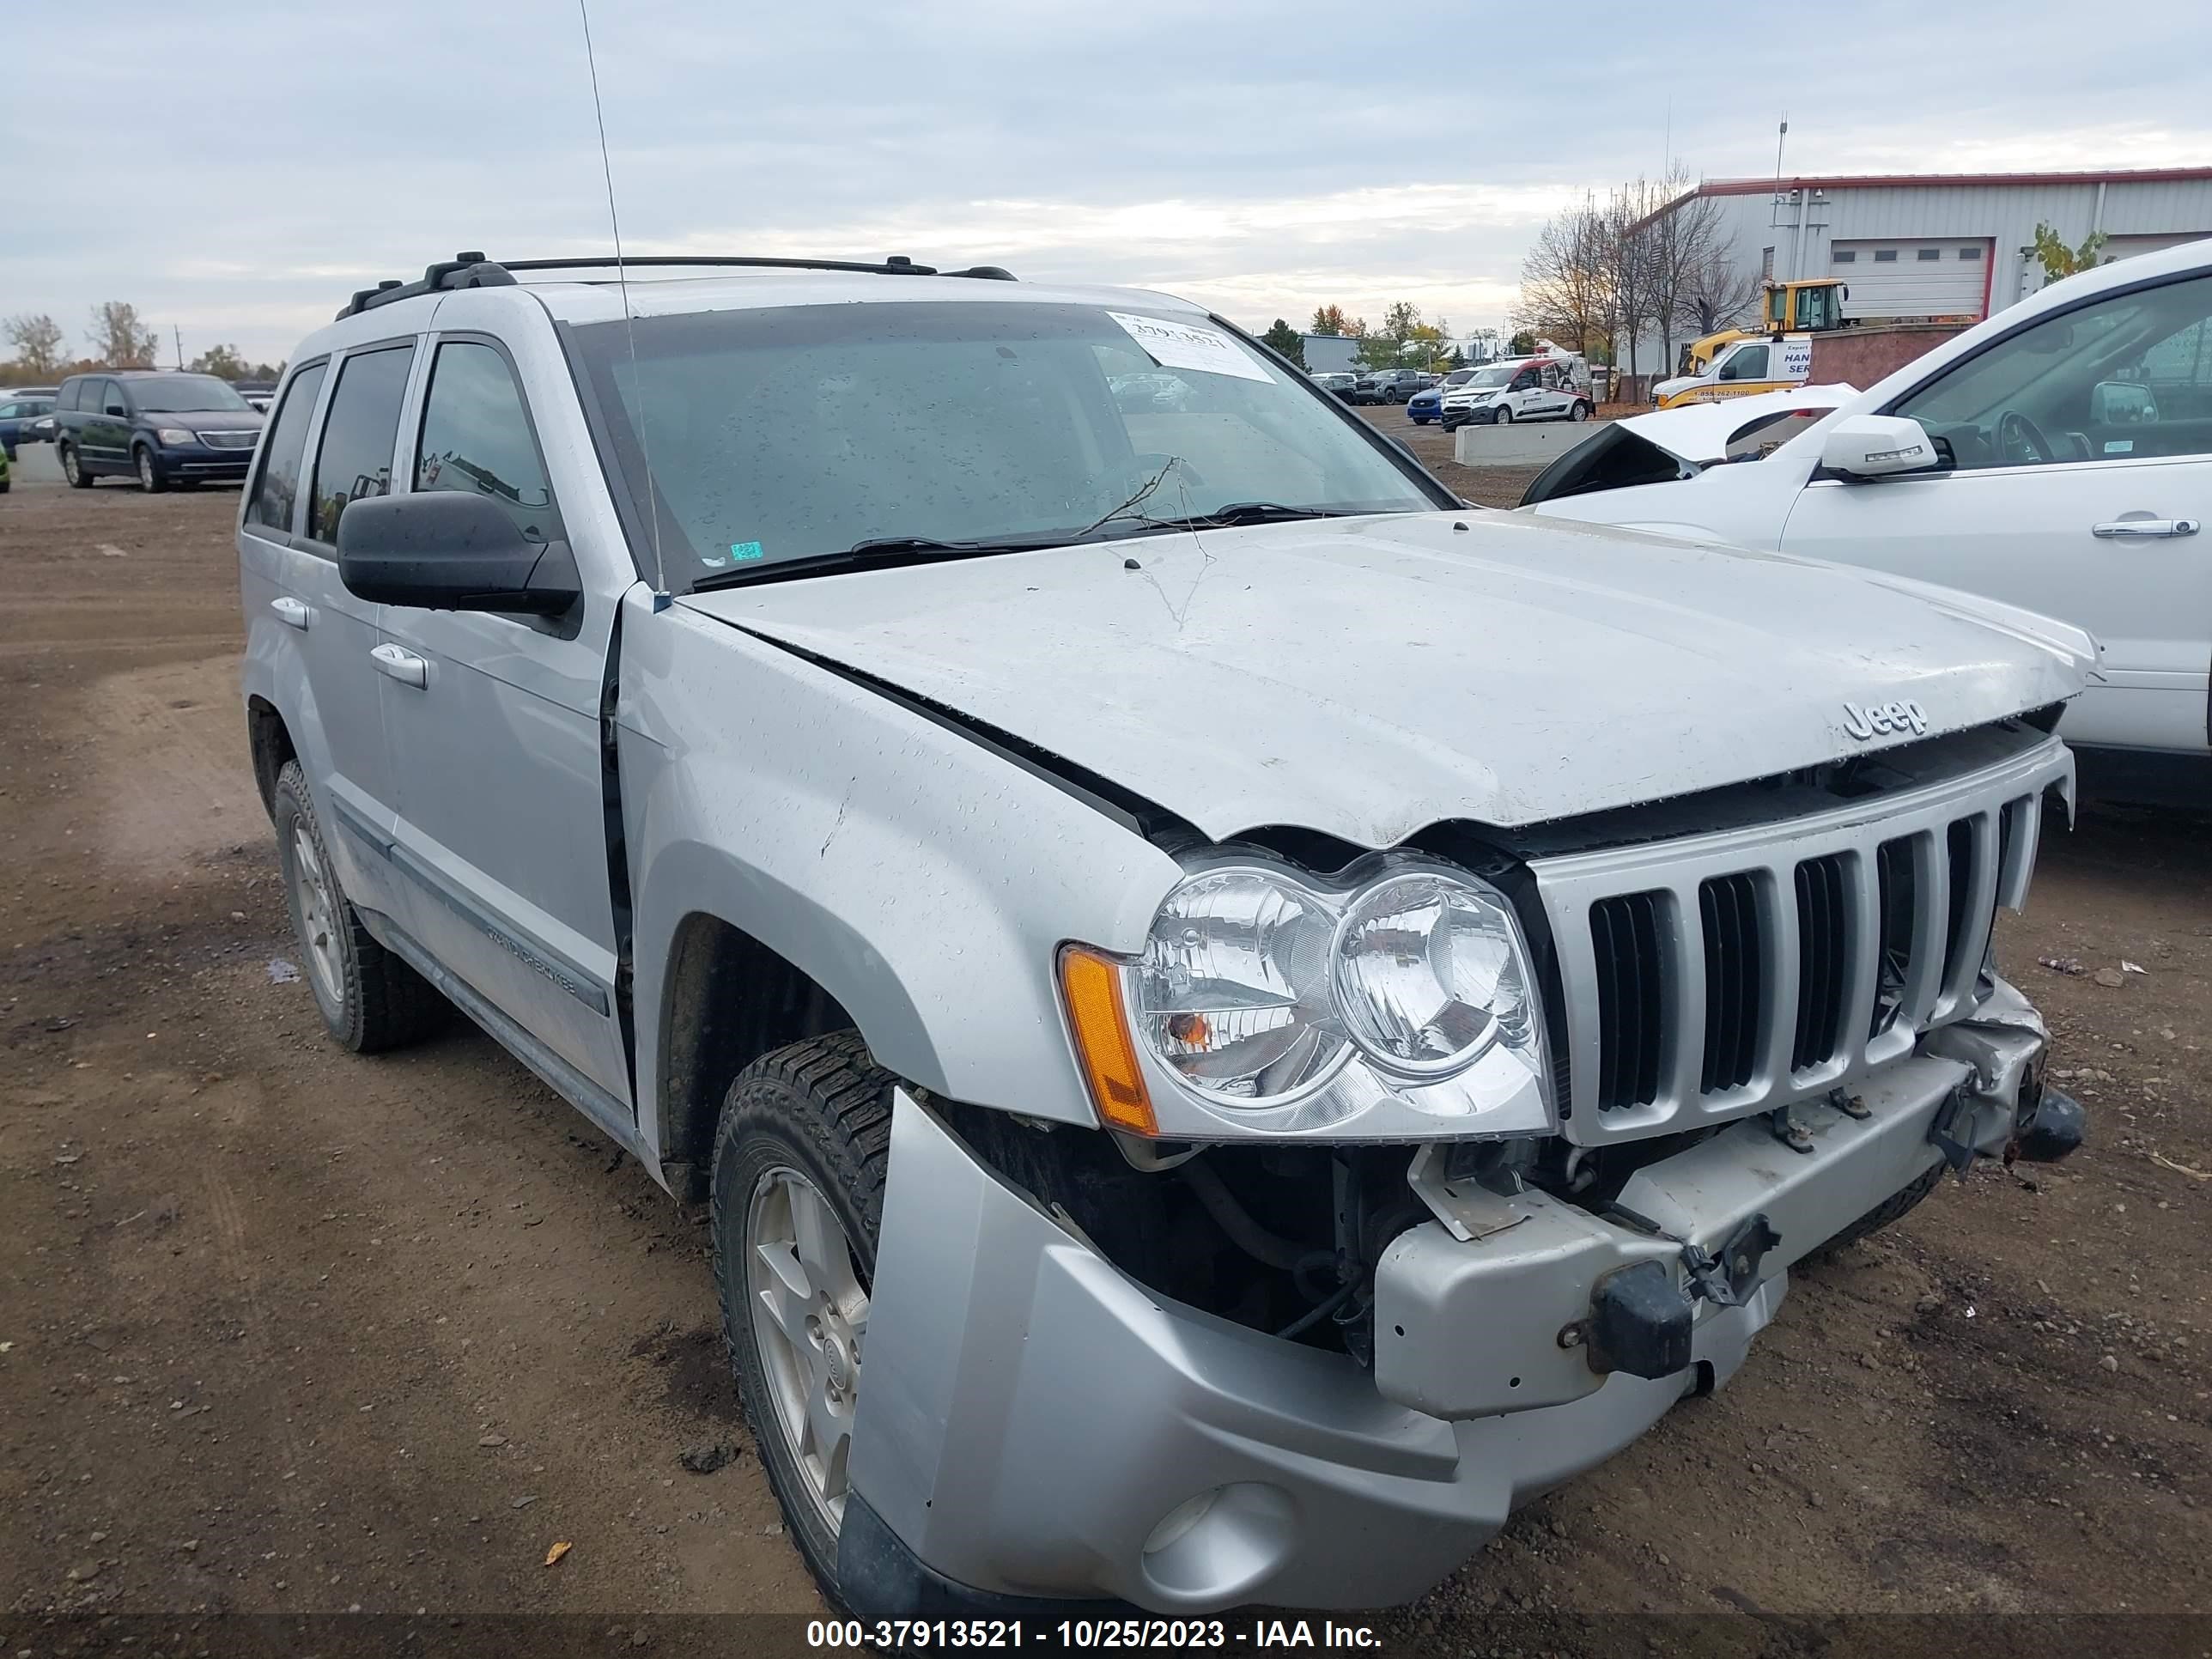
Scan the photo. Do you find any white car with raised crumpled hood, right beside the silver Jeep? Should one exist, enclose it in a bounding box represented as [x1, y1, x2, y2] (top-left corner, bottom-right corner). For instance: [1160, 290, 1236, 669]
[1528, 241, 2212, 803]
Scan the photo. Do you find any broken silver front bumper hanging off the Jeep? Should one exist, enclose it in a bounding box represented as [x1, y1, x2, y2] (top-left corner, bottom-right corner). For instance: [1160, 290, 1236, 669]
[838, 980, 2044, 1617]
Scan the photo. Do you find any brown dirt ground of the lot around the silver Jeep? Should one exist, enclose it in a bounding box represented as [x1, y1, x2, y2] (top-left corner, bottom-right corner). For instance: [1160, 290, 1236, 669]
[0, 448, 2212, 1655]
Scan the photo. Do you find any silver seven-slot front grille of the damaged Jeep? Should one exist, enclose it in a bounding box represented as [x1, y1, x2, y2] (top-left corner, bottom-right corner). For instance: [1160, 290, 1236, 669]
[1533, 741, 2073, 1139]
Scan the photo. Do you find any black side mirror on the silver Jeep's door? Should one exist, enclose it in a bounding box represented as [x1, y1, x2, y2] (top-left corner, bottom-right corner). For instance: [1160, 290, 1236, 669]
[338, 500, 584, 617]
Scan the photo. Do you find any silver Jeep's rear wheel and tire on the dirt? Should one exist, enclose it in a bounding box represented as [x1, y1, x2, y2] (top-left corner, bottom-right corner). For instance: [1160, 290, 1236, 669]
[272, 761, 445, 1055]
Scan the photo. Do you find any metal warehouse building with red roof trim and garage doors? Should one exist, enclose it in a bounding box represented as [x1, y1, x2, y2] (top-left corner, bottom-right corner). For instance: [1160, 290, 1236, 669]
[1627, 168, 2212, 358]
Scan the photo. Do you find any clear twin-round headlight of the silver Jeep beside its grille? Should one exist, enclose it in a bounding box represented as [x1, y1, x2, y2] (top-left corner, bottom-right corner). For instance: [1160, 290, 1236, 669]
[1119, 856, 1558, 1139]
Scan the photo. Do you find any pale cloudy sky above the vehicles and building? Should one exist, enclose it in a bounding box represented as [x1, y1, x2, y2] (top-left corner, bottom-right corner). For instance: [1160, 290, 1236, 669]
[0, 0, 2212, 361]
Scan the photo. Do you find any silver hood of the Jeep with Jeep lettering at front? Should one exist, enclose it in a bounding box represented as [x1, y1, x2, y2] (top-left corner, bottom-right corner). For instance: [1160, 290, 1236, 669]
[679, 508, 2094, 848]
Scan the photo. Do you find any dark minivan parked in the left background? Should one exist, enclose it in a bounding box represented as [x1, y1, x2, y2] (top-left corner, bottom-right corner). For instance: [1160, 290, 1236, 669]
[53, 369, 261, 493]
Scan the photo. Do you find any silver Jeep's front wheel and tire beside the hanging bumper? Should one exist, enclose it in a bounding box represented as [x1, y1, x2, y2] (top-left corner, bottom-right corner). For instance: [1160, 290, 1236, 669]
[714, 1030, 894, 1610]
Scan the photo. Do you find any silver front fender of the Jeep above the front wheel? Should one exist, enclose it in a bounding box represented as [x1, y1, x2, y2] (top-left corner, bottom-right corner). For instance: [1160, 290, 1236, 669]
[617, 591, 1182, 1137]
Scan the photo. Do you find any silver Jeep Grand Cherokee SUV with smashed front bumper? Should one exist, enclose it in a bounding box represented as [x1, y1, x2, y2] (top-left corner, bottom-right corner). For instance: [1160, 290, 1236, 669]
[239, 254, 2093, 1614]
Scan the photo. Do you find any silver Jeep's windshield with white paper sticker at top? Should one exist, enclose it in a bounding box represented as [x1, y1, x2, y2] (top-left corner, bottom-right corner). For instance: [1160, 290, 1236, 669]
[573, 301, 1443, 591]
